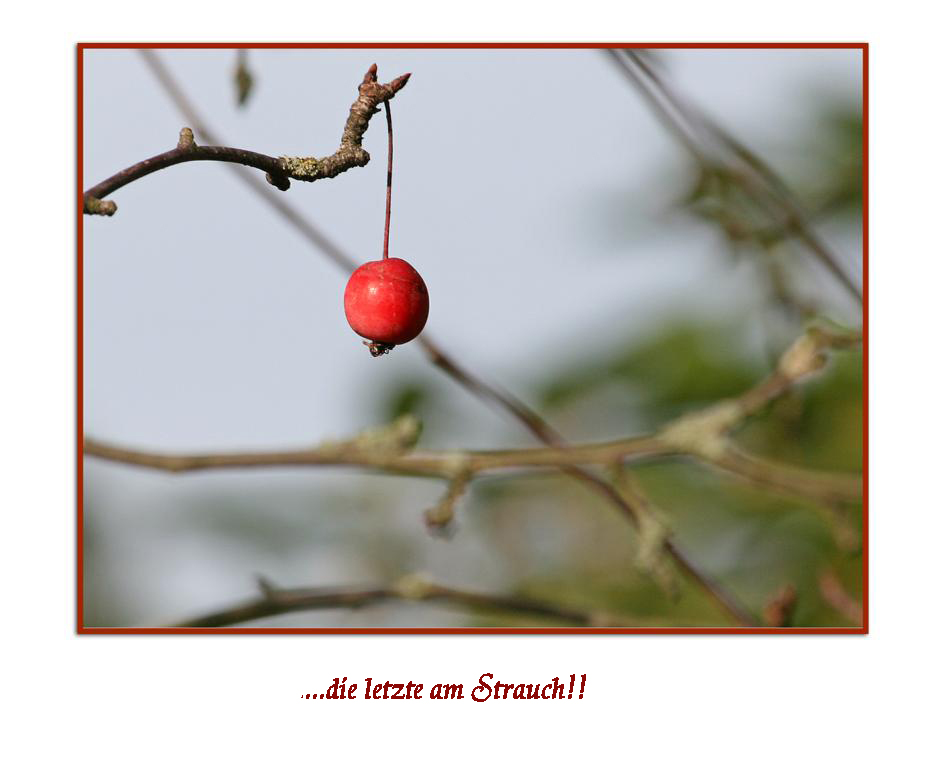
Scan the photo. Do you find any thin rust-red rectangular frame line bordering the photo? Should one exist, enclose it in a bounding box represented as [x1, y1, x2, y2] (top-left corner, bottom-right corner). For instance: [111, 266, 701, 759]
[76, 42, 870, 635]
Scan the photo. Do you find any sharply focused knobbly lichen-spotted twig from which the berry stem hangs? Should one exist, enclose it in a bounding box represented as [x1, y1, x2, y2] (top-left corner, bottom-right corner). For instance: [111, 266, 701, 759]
[83, 64, 409, 216]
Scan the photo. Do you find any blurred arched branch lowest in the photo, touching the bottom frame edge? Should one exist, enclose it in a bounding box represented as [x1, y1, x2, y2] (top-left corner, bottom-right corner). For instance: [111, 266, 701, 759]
[175, 575, 656, 627]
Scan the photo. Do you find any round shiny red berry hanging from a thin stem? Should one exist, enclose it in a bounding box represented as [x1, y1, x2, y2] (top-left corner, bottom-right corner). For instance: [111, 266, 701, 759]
[343, 258, 429, 356]
